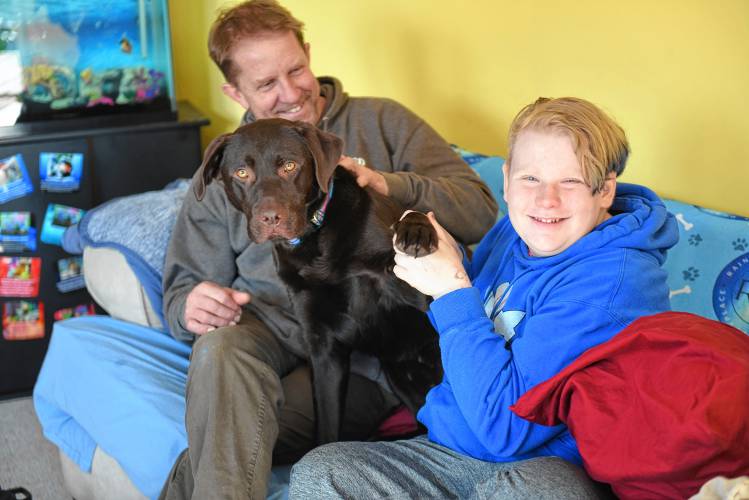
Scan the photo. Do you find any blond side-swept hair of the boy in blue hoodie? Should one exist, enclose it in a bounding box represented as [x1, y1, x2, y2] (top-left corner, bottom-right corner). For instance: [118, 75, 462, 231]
[507, 97, 629, 194]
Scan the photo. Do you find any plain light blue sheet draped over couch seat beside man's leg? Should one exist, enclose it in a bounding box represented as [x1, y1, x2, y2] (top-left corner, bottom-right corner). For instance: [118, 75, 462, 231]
[34, 316, 289, 499]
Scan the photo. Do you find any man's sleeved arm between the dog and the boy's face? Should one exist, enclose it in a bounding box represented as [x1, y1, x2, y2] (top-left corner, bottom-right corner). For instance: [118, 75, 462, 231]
[330, 98, 497, 244]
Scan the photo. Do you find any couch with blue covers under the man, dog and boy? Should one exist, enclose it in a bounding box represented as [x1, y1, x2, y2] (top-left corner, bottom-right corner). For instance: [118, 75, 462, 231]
[34, 148, 749, 500]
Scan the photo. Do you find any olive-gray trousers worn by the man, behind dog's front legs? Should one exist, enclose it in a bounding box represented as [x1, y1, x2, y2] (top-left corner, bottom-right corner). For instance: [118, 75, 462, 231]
[160, 311, 399, 500]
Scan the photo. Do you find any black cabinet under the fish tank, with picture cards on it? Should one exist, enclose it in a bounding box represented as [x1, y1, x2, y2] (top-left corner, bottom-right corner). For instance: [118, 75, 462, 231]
[0, 102, 208, 398]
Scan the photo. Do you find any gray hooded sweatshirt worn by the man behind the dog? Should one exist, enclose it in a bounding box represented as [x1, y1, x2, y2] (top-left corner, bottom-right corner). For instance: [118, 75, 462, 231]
[163, 77, 497, 341]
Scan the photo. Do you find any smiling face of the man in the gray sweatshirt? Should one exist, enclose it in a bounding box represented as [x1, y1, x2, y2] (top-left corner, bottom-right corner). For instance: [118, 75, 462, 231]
[223, 31, 325, 125]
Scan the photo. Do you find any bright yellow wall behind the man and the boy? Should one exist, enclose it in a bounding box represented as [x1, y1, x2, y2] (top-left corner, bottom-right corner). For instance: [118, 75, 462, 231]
[170, 0, 749, 216]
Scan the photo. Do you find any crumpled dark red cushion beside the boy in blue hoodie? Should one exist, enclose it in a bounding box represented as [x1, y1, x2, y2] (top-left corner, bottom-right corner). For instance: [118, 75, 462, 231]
[511, 313, 749, 498]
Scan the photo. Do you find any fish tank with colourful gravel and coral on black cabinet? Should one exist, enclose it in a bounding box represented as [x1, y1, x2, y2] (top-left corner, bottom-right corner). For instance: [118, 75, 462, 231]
[0, 0, 176, 132]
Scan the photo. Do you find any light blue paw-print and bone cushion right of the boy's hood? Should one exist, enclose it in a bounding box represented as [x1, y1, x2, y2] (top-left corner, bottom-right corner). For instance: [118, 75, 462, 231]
[664, 200, 749, 334]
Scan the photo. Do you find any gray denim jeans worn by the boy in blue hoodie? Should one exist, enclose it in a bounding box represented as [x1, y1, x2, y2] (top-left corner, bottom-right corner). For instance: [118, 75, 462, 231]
[289, 436, 610, 500]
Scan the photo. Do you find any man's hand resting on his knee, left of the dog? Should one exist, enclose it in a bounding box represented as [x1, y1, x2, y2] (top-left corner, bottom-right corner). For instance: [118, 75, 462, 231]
[184, 281, 250, 335]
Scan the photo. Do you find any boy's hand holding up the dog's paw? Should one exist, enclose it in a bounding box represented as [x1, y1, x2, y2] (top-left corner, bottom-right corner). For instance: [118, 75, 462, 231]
[393, 211, 471, 299]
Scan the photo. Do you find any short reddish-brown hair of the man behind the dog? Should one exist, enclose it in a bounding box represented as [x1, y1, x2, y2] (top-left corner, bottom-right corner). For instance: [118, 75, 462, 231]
[208, 0, 304, 83]
